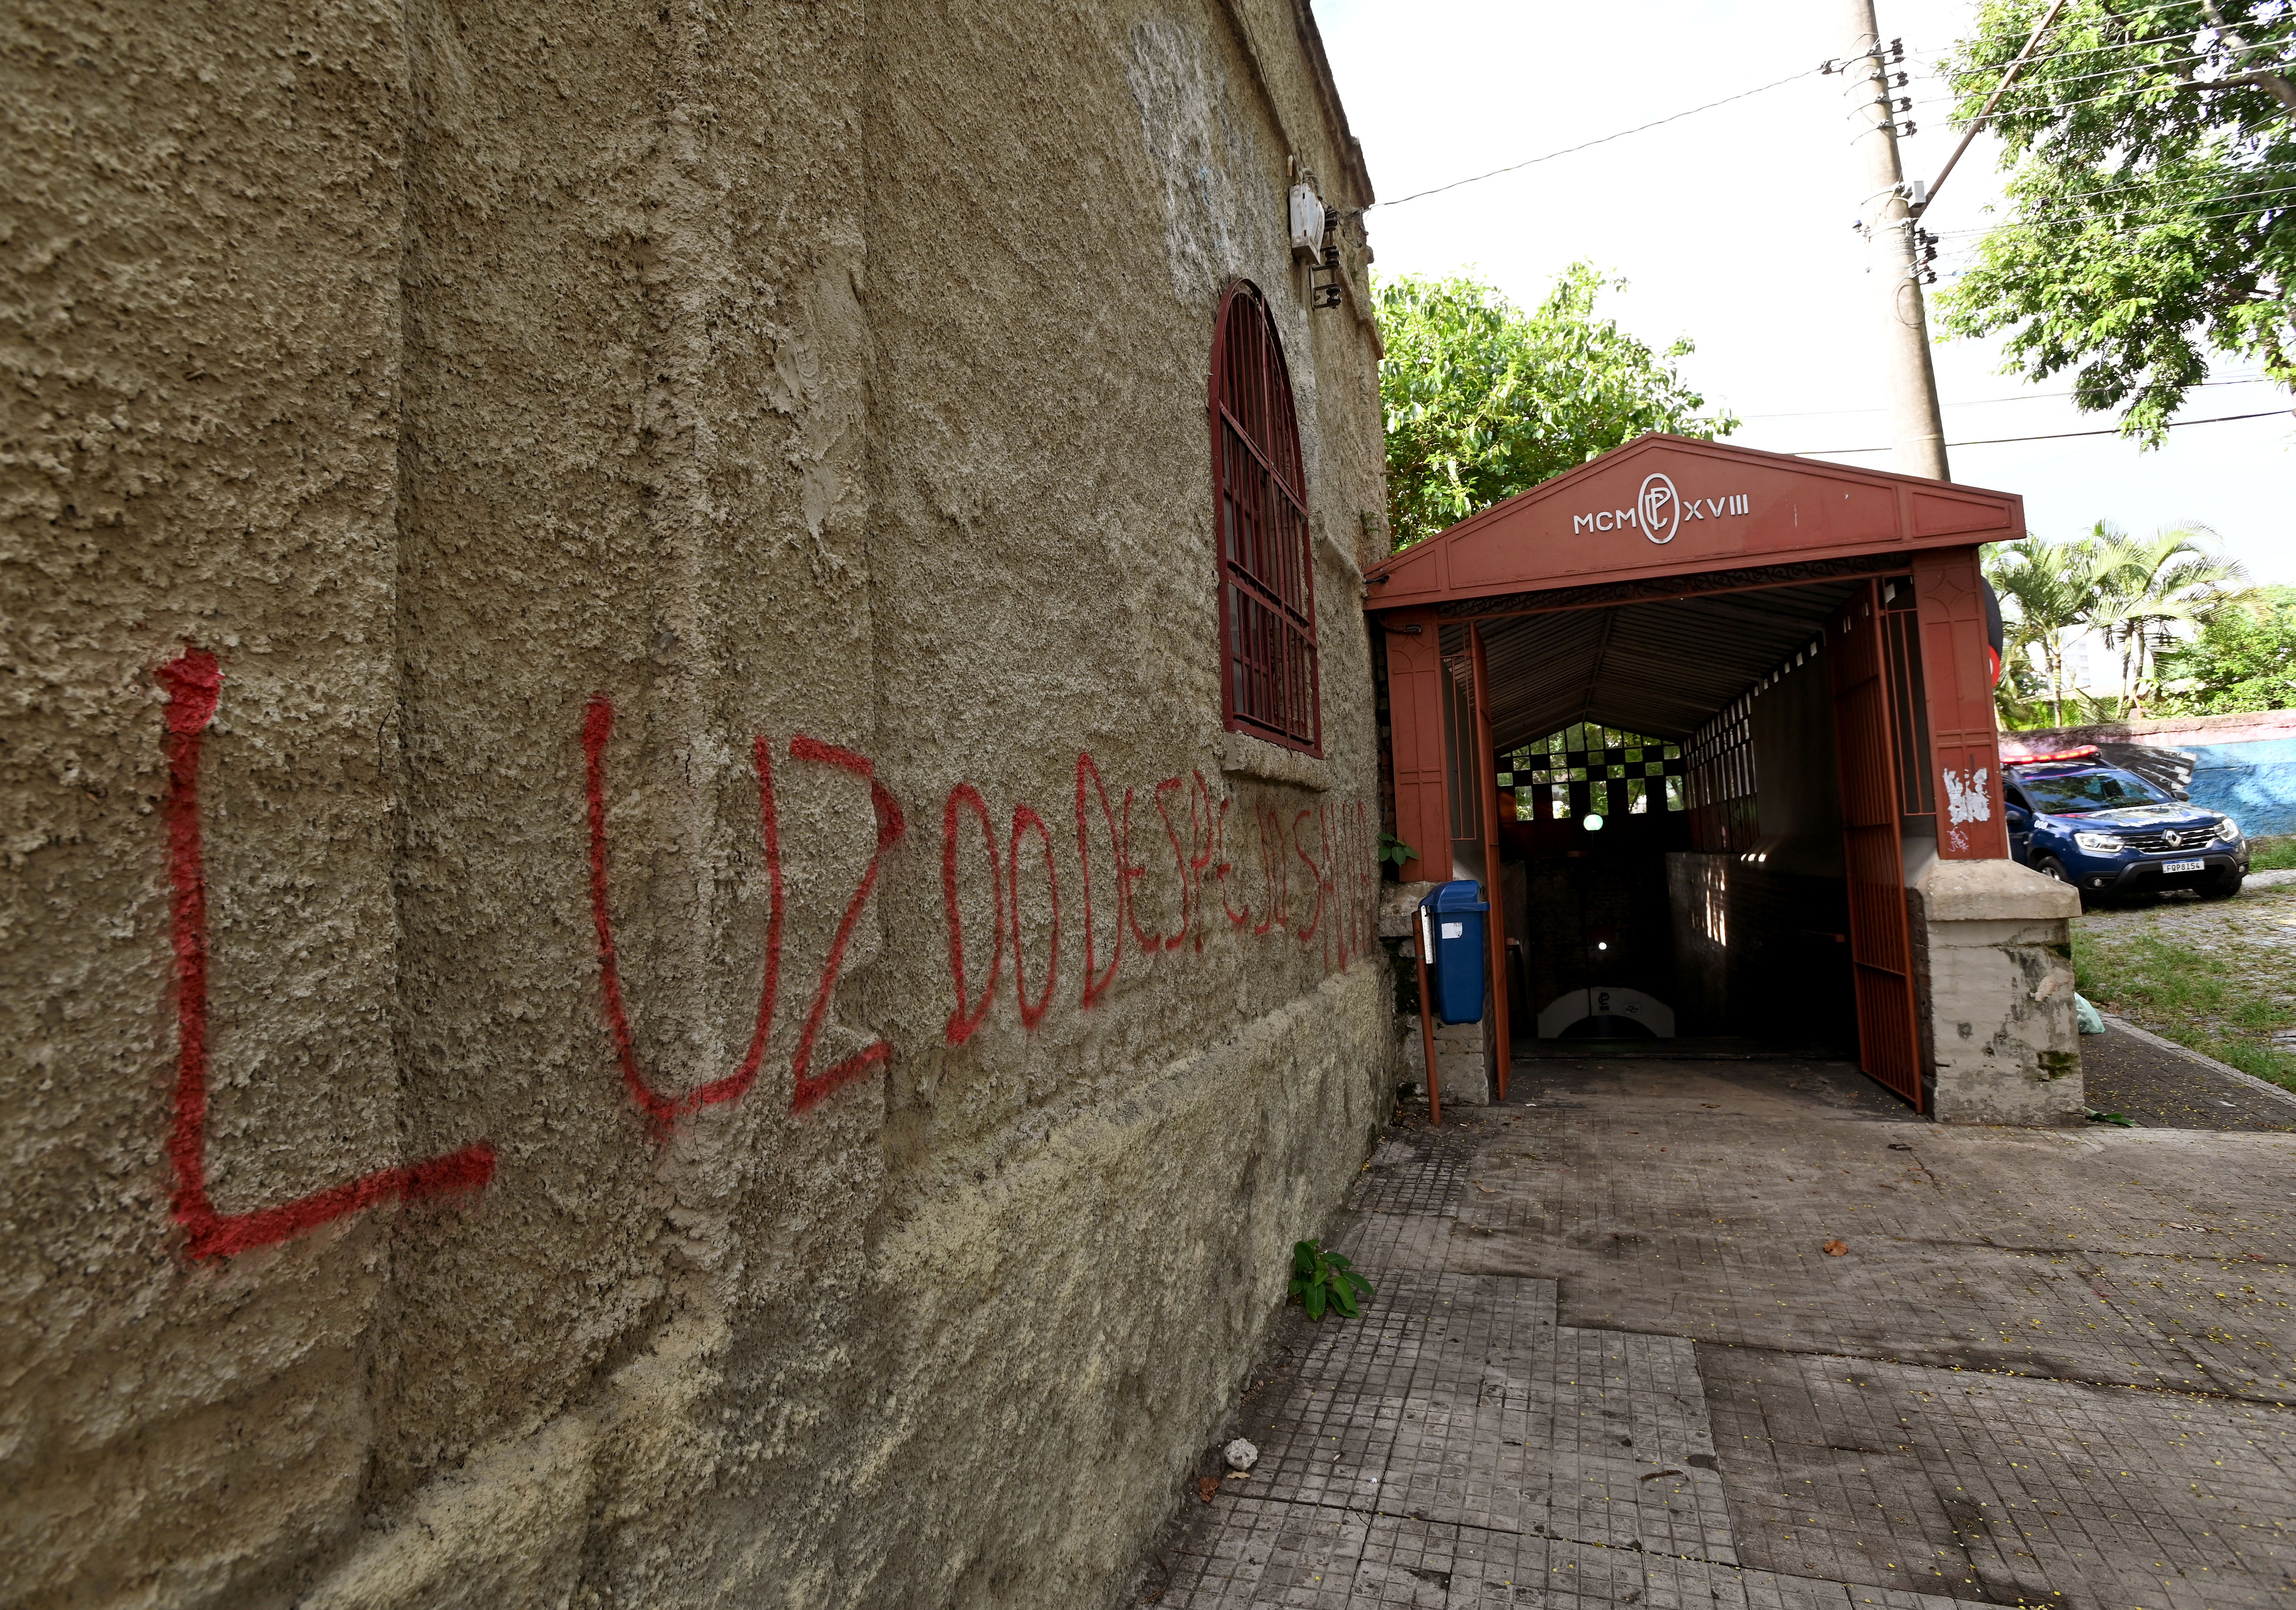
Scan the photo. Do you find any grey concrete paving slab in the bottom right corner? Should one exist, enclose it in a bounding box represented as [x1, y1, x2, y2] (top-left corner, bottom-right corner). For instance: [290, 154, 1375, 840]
[1702, 1348, 2296, 1605]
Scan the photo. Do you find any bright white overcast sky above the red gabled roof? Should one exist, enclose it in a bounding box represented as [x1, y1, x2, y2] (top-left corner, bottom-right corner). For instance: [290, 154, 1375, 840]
[1315, 0, 2296, 583]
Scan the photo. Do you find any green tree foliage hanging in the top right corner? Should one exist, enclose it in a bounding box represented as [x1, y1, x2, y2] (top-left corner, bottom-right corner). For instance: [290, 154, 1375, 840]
[1940, 0, 2296, 446]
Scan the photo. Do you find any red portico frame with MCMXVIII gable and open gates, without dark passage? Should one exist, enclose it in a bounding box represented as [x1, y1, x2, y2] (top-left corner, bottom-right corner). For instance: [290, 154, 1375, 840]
[1366, 434, 2025, 1105]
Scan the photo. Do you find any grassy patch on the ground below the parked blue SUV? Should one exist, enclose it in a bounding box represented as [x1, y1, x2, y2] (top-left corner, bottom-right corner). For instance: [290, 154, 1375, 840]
[2073, 894, 2296, 1091]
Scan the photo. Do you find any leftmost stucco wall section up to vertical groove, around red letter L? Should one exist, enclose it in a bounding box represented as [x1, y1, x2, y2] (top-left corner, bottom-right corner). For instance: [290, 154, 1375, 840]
[0, 0, 409, 1605]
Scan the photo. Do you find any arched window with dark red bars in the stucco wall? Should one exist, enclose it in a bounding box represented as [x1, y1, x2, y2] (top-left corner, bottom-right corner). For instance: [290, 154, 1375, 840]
[1212, 280, 1323, 756]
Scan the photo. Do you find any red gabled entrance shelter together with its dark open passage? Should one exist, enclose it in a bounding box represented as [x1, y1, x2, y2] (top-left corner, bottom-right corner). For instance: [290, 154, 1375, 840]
[1366, 436, 2025, 1107]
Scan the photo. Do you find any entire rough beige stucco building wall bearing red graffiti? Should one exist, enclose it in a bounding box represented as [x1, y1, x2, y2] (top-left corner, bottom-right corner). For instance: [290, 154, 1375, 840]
[0, 0, 1391, 1605]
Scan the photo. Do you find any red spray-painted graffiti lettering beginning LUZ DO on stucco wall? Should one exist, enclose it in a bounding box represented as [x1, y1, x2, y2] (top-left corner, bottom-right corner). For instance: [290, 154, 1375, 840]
[156, 648, 1378, 1259]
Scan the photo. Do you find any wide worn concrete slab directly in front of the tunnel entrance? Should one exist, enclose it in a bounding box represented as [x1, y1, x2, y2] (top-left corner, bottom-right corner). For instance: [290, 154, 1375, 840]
[1449, 1072, 2296, 1401]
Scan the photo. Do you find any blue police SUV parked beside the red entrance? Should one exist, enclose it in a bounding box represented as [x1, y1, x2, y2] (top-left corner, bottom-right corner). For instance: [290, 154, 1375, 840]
[2002, 746, 2248, 907]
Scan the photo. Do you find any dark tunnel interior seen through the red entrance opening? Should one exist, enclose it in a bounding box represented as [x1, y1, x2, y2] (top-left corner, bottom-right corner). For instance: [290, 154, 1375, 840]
[1444, 579, 1917, 1056]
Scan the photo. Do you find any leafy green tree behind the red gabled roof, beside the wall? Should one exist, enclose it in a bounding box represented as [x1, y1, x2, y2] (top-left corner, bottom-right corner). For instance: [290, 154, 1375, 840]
[1378, 262, 1738, 549]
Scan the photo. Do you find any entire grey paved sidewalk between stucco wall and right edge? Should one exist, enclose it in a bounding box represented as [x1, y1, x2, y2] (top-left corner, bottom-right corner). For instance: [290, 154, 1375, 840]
[1132, 1061, 2296, 1610]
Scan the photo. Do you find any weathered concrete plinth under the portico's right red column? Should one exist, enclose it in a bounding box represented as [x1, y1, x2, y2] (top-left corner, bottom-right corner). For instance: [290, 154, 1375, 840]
[1906, 861, 2085, 1125]
